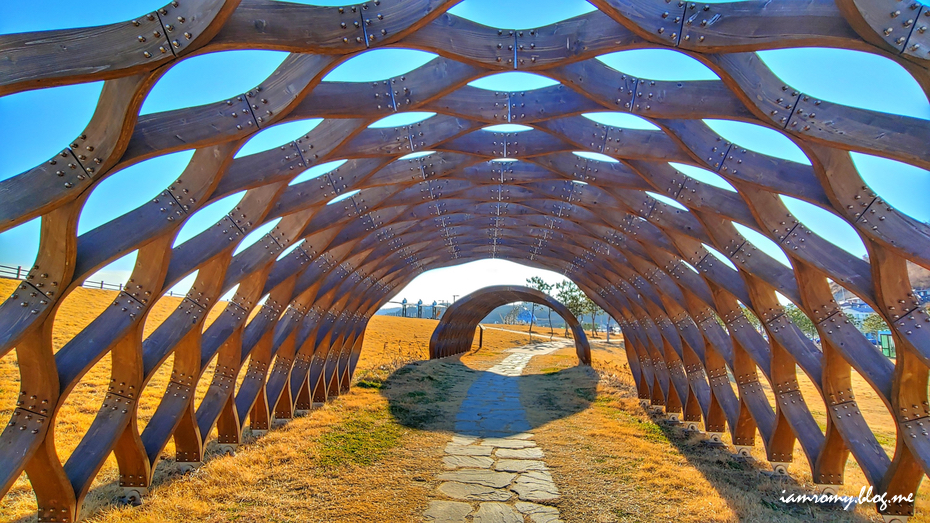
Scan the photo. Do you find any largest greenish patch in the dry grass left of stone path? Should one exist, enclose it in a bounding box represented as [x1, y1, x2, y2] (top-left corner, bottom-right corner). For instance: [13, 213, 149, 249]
[319, 409, 403, 468]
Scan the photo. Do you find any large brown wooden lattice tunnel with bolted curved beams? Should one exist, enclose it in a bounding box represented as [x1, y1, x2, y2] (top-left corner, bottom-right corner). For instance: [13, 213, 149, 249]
[0, 0, 930, 521]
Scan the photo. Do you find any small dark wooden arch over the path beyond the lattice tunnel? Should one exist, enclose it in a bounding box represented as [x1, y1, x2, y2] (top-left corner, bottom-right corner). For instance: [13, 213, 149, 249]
[429, 285, 591, 365]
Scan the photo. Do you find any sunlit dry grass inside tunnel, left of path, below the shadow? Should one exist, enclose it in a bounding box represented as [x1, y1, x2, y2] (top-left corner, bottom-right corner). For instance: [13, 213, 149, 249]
[85, 374, 451, 522]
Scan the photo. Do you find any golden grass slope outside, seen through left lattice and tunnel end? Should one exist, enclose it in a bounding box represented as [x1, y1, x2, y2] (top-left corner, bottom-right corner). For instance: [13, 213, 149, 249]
[0, 279, 544, 521]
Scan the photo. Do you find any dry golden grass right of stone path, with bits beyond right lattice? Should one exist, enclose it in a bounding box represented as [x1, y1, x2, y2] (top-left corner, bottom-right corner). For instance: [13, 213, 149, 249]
[521, 346, 930, 522]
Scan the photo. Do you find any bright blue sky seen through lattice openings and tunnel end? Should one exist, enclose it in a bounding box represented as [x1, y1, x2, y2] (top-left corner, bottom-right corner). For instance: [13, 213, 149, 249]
[0, 0, 930, 301]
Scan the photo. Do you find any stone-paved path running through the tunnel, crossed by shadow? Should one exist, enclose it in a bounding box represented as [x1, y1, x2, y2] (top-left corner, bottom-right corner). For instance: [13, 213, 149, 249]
[423, 341, 571, 523]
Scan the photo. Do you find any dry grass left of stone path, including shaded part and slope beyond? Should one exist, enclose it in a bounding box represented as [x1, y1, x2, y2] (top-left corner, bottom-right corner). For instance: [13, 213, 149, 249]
[94, 316, 511, 523]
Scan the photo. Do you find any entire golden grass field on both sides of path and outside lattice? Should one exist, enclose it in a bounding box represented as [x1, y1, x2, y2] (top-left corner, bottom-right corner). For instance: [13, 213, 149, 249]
[0, 280, 930, 522]
